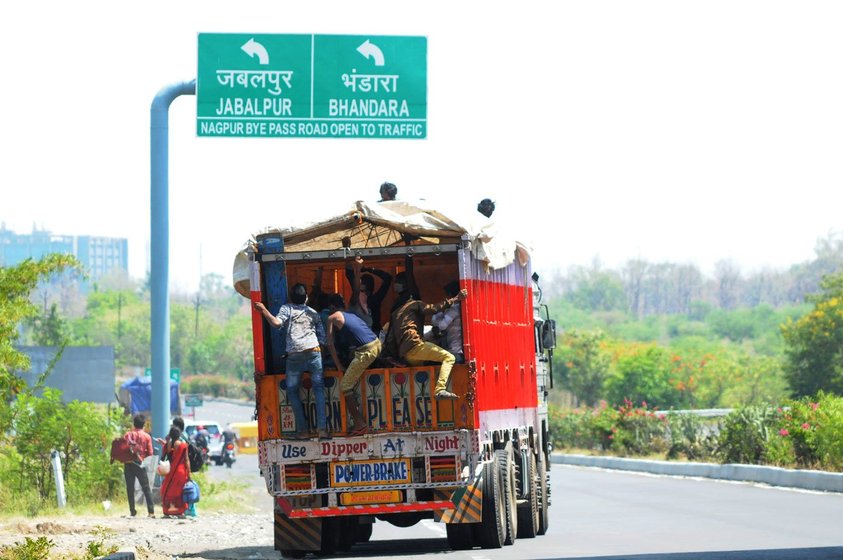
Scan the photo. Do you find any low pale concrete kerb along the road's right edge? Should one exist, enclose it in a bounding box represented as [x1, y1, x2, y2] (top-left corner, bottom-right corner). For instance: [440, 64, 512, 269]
[551, 453, 843, 492]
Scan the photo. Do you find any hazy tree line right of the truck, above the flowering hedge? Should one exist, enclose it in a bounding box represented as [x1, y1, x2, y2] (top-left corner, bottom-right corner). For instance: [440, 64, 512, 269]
[550, 234, 843, 409]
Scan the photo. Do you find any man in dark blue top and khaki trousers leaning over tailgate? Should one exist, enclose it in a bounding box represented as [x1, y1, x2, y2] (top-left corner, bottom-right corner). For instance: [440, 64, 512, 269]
[327, 294, 381, 436]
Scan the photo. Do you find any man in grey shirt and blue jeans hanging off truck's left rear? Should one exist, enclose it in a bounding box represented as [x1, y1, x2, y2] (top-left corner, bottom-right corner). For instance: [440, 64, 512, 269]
[255, 283, 331, 439]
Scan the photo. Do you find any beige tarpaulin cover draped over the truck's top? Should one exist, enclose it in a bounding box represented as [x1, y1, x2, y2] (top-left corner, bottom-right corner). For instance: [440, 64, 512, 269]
[233, 200, 531, 298]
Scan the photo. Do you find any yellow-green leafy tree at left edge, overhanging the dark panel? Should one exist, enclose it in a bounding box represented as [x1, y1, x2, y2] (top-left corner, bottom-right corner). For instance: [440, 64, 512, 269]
[0, 254, 81, 437]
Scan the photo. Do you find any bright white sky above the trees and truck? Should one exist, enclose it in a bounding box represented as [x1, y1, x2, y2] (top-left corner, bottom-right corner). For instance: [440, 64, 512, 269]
[0, 0, 843, 293]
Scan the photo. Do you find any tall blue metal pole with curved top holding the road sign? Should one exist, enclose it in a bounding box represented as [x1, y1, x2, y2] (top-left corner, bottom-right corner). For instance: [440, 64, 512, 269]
[150, 80, 196, 444]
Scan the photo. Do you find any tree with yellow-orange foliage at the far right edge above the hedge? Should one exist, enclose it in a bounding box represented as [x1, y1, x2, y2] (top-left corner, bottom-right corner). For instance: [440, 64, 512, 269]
[782, 273, 843, 397]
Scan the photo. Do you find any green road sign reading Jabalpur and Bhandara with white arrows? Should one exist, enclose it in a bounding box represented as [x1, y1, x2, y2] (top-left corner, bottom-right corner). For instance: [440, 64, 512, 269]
[196, 33, 427, 139]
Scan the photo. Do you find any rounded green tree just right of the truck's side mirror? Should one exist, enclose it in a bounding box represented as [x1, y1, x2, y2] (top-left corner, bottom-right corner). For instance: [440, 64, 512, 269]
[561, 330, 611, 406]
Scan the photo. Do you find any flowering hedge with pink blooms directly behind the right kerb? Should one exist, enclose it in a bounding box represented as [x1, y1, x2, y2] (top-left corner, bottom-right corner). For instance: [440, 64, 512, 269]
[549, 393, 843, 472]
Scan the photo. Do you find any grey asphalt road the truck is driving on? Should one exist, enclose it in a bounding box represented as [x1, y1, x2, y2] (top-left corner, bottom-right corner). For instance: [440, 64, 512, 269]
[203, 403, 843, 560]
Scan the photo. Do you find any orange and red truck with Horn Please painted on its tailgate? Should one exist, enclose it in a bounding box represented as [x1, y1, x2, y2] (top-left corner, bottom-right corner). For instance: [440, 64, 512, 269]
[234, 201, 556, 558]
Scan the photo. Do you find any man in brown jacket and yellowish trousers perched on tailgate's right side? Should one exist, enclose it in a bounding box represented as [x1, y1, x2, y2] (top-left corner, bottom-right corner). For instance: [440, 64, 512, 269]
[387, 284, 468, 399]
